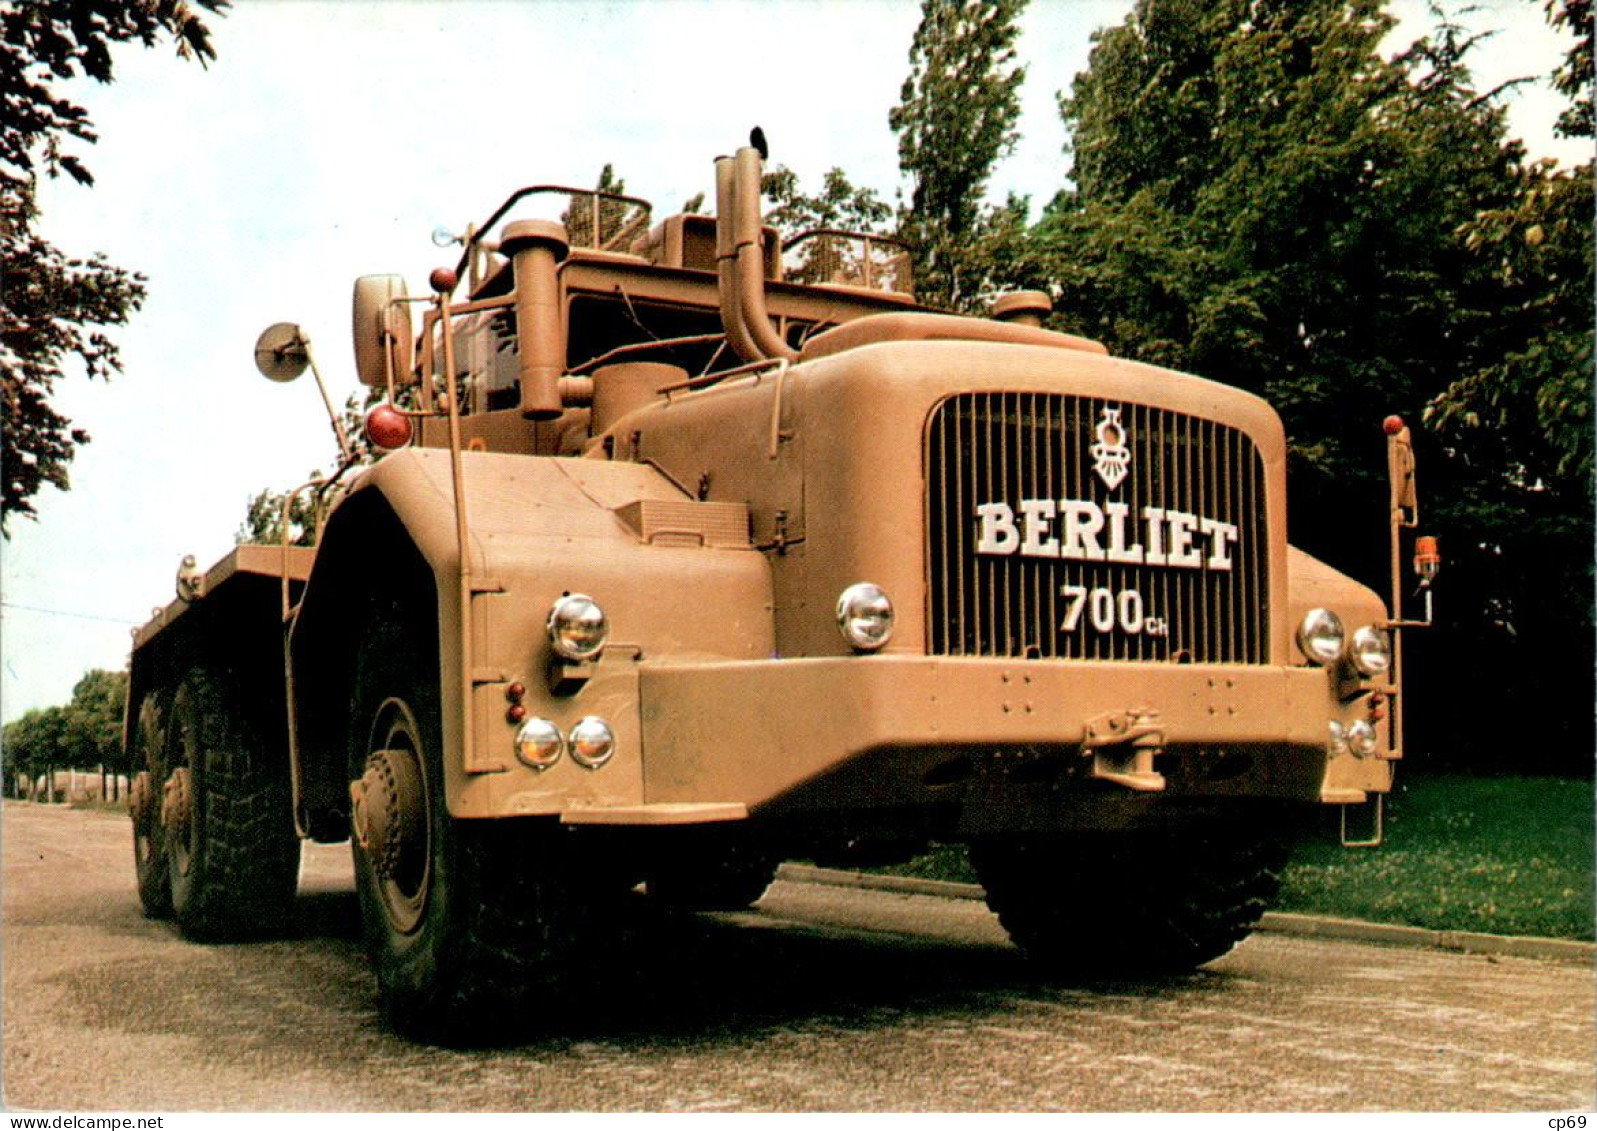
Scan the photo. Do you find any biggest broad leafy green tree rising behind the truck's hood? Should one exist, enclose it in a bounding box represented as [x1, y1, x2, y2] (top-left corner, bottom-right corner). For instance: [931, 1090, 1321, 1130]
[1038, 0, 1517, 555]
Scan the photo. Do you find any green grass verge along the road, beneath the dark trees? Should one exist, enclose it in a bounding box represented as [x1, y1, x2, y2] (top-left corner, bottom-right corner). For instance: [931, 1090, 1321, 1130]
[882, 772, 1597, 939]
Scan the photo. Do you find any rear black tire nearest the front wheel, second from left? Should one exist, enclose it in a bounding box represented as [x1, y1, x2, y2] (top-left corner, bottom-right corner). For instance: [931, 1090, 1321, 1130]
[160, 665, 299, 943]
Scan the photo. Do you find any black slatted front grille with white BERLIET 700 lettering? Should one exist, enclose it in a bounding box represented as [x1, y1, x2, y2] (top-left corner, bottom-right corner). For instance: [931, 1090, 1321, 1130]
[926, 393, 1270, 663]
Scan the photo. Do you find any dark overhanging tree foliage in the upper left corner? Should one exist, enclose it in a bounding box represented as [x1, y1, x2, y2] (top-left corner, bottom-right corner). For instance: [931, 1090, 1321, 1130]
[0, 0, 228, 537]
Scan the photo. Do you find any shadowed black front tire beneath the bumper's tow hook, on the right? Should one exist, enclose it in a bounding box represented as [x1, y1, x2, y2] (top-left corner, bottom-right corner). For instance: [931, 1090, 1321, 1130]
[971, 823, 1290, 978]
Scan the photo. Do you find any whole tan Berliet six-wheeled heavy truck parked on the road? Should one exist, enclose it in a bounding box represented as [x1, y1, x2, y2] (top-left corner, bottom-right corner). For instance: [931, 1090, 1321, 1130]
[126, 136, 1434, 1034]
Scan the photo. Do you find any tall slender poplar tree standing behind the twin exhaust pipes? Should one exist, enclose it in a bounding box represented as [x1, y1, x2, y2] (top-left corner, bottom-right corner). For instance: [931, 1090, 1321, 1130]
[888, 0, 1025, 308]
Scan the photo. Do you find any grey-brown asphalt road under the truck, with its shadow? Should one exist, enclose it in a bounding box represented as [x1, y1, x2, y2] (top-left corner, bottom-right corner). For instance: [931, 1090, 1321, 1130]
[0, 802, 1597, 1112]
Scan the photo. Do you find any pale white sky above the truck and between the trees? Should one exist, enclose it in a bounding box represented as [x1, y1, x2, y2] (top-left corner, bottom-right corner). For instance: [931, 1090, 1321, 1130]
[0, 0, 1583, 720]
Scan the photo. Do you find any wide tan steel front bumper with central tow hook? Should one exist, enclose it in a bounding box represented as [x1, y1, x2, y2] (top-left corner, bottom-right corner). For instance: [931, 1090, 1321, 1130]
[639, 655, 1389, 815]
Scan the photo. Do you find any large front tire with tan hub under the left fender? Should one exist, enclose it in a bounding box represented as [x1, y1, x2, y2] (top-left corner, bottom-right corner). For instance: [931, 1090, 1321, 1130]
[350, 607, 600, 1045]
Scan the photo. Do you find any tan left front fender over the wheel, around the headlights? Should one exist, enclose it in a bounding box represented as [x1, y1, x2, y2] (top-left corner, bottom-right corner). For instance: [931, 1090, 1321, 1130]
[292, 449, 773, 816]
